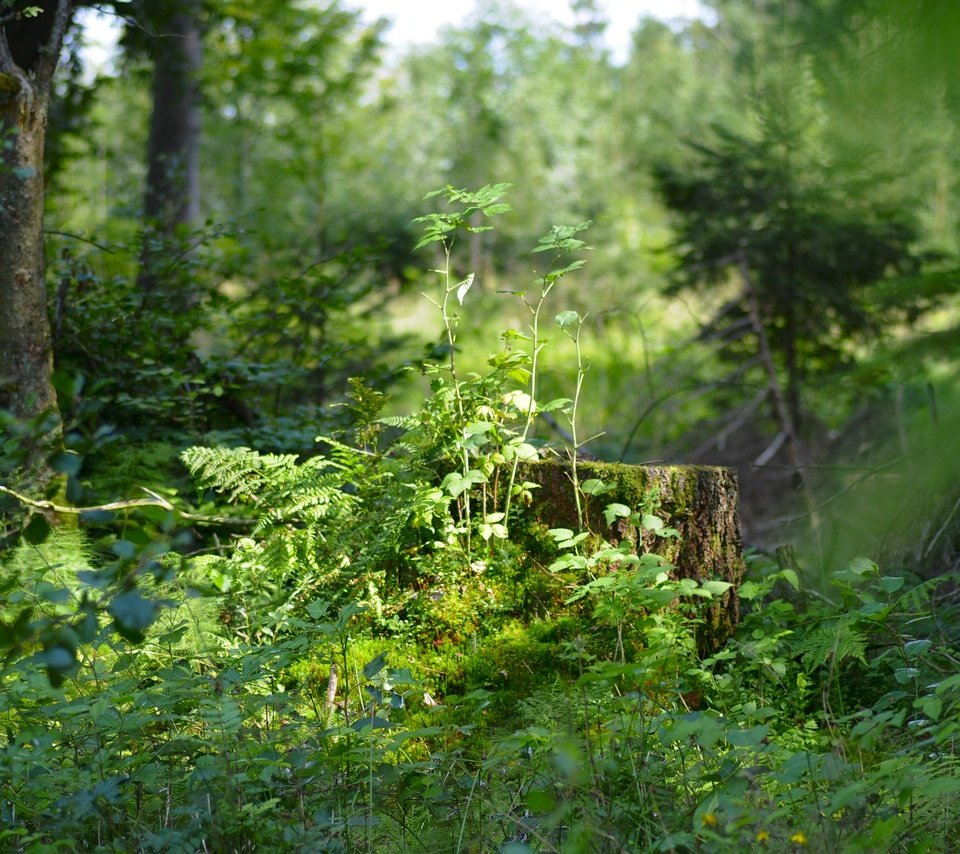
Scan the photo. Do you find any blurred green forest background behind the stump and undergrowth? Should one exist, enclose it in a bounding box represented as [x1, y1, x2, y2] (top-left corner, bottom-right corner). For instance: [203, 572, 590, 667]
[11, 0, 960, 571]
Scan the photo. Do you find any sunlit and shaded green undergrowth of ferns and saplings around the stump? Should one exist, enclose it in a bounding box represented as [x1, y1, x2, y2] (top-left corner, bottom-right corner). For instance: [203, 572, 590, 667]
[0, 187, 960, 854]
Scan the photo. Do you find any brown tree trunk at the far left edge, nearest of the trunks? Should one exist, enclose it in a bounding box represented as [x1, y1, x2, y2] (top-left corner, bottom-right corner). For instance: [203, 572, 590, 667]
[0, 0, 71, 485]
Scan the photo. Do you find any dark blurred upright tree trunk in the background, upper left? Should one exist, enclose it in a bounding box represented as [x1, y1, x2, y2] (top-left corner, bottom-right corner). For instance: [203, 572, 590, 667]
[139, 0, 203, 302]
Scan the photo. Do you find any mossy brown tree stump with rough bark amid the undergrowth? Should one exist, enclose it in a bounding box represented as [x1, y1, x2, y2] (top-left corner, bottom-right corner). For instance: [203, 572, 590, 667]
[518, 461, 744, 651]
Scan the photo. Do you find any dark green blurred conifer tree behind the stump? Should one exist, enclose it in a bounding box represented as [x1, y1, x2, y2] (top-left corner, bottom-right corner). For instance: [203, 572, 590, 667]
[657, 120, 918, 424]
